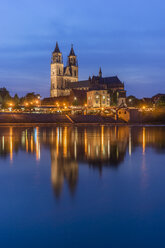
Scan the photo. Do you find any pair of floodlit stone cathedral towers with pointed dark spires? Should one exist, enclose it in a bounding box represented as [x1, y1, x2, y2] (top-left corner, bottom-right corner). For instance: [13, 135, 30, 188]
[50, 42, 78, 97]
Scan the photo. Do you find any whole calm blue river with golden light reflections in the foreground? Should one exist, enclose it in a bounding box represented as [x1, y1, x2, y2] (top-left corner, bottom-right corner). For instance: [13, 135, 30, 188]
[0, 126, 165, 248]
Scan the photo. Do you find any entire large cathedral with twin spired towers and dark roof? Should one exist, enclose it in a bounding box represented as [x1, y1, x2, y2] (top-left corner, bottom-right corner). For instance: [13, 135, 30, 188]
[50, 43, 126, 106]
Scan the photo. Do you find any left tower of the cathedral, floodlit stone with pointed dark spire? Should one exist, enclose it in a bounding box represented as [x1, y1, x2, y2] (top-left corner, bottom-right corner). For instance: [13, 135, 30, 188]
[50, 42, 64, 97]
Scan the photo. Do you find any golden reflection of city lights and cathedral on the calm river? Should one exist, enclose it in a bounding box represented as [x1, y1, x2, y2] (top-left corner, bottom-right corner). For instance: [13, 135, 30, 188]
[0, 126, 165, 197]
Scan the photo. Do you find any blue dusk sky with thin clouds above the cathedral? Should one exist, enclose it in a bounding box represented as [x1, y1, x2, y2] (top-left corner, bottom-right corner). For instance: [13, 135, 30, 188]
[0, 0, 165, 97]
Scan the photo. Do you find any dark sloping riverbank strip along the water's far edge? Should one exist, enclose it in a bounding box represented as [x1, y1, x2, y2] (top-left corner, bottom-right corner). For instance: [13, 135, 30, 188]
[0, 112, 165, 126]
